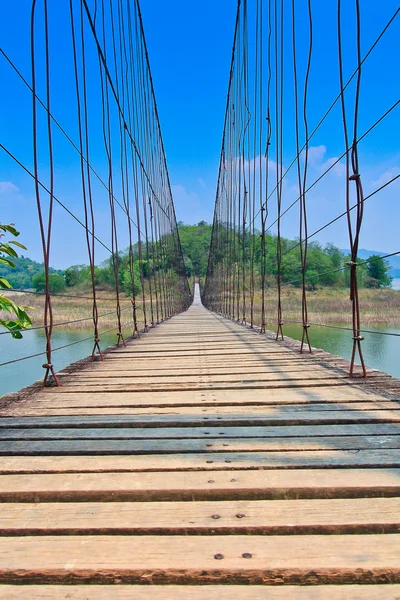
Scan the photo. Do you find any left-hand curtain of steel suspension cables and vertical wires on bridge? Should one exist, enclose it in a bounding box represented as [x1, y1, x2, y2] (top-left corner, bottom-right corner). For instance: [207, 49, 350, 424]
[0, 0, 192, 385]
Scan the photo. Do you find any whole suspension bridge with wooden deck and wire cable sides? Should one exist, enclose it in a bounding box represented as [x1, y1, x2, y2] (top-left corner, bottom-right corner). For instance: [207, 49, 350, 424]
[0, 0, 400, 600]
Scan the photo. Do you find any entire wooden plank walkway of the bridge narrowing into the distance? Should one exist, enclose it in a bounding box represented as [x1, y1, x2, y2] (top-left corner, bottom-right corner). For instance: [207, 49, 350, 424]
[0, 284, 400, 600]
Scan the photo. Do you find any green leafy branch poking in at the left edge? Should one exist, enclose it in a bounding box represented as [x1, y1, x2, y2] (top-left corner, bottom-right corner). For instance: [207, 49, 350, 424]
[0, 224, 32, 339]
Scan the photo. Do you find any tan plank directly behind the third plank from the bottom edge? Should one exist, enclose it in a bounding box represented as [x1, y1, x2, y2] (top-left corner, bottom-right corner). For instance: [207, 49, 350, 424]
[0, 469, 400, 502]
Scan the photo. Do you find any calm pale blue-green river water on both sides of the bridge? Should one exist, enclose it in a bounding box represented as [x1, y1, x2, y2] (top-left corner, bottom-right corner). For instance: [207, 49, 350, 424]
[0, 323, 400, 397]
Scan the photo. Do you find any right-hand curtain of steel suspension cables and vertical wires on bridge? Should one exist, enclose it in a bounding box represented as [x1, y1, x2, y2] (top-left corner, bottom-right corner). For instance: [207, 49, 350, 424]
[202, 0, 400, 377]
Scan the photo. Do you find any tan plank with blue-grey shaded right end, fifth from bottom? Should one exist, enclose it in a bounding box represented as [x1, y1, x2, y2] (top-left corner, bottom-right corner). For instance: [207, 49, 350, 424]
[0, 450, 400, 478]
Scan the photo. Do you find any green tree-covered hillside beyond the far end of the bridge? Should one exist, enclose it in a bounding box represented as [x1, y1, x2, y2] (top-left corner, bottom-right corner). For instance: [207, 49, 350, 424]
[0, 221, 391, 295]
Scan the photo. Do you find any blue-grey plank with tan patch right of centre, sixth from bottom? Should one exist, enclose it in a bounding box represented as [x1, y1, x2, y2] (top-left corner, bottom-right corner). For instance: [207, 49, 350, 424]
[0, 430, 400, 456]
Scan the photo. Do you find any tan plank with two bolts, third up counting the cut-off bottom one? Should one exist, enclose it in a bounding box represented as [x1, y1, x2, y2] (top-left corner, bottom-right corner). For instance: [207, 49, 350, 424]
[0, 498, 400, 536]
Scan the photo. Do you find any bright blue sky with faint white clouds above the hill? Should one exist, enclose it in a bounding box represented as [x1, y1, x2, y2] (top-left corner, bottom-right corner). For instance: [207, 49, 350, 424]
[0, 0, 400, 267]
